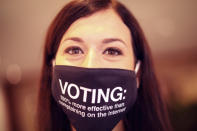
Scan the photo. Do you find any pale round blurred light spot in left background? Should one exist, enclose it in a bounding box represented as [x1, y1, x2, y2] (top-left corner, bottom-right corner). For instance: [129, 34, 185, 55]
[6, 64, 22, 84]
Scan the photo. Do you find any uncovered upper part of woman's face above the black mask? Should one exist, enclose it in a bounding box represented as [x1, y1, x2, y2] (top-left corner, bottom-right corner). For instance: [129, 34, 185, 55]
[55, 9, 134, 70]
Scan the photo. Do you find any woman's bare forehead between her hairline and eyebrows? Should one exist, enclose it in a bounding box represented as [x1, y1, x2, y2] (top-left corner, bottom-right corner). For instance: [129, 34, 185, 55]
[60, 9, 131, 41]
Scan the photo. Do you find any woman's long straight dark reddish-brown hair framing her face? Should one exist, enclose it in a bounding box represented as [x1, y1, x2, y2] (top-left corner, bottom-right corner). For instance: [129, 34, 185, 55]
[37, 0, 171, 131]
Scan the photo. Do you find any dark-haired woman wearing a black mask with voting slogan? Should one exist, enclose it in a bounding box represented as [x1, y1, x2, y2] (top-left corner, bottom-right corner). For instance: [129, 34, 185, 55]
[38, 0, 171, 131]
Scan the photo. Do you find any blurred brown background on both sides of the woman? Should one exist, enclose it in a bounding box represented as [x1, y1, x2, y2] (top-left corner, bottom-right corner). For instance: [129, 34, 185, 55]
[0, 0, 197, 131]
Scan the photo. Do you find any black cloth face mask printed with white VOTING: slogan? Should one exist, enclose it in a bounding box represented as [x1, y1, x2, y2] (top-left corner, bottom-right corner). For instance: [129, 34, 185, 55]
[52, 61, 139, 131]
